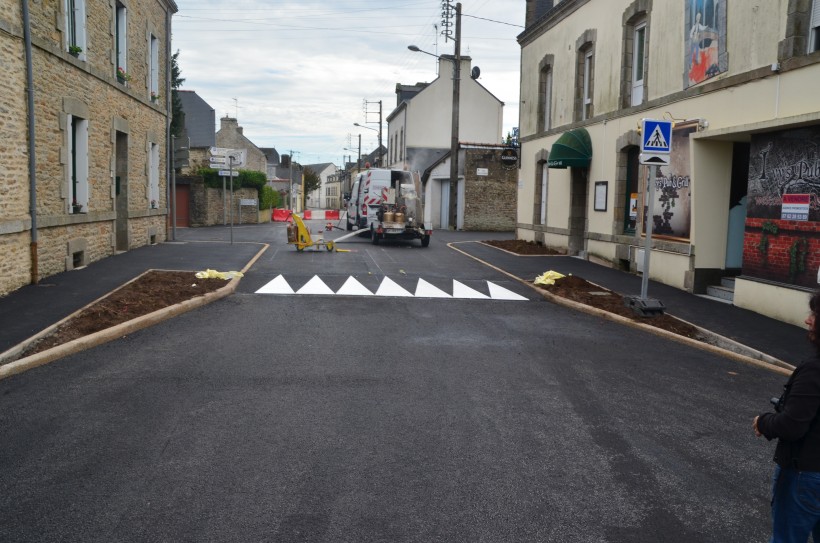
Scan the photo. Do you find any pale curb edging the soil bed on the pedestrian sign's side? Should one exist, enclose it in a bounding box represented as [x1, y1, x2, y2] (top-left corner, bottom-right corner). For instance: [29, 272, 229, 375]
[447, 242, 794, 376]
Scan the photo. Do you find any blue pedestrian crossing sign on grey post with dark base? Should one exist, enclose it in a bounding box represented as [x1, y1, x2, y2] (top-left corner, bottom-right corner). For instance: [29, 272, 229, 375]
[627, 119, 672, 317]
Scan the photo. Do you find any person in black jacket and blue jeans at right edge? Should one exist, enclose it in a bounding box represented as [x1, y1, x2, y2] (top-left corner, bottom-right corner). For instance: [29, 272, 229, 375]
[753, 292, 820, 543]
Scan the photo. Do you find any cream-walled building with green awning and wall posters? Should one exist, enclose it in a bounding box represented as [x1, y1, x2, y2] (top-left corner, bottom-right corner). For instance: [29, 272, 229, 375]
[517, 0, 820, 325]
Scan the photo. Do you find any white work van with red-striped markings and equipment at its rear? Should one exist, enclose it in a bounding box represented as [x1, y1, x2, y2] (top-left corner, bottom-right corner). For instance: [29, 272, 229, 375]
[346, 169, 432, 247]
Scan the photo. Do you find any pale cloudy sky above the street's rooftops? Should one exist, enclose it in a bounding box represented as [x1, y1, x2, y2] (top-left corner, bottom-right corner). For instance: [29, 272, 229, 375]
[172, 0, 525, 164]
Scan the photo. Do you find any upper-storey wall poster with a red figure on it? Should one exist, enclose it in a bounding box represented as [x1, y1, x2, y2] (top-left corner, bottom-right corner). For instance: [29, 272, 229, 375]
[683, 0, 729, 88]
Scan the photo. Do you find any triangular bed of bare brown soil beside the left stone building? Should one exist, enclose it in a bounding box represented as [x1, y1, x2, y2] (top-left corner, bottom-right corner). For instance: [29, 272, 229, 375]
[21, 271, 228, 357]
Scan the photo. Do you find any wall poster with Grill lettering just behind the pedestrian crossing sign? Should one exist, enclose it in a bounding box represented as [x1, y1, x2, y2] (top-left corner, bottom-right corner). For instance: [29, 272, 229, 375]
[644, 122, 697, 241]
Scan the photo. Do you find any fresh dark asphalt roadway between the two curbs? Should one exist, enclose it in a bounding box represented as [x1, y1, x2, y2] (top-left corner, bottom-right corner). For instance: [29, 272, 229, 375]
[0, 222, 784, 543]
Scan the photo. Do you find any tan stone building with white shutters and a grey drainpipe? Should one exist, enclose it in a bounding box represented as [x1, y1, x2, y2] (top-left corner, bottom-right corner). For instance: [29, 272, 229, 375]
[0, 0, 177, 294]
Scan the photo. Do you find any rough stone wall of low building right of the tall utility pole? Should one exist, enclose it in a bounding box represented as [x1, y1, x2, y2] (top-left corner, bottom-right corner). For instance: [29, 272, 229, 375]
[464, 148, 518, 232]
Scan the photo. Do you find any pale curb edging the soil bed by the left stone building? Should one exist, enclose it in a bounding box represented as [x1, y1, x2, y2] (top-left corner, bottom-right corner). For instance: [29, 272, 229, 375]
[0, 244, 269, 380]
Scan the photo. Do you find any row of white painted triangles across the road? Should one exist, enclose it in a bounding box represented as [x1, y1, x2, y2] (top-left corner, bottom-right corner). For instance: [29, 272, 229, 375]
[256, 275, 528, 301]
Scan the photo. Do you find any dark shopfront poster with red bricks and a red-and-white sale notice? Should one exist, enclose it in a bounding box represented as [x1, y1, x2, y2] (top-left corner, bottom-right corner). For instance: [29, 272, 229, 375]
[743, 126, 820, 288]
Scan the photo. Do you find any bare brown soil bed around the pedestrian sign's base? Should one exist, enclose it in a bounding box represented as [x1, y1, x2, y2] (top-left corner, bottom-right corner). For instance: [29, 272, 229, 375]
[539, 275, 705, 341]
